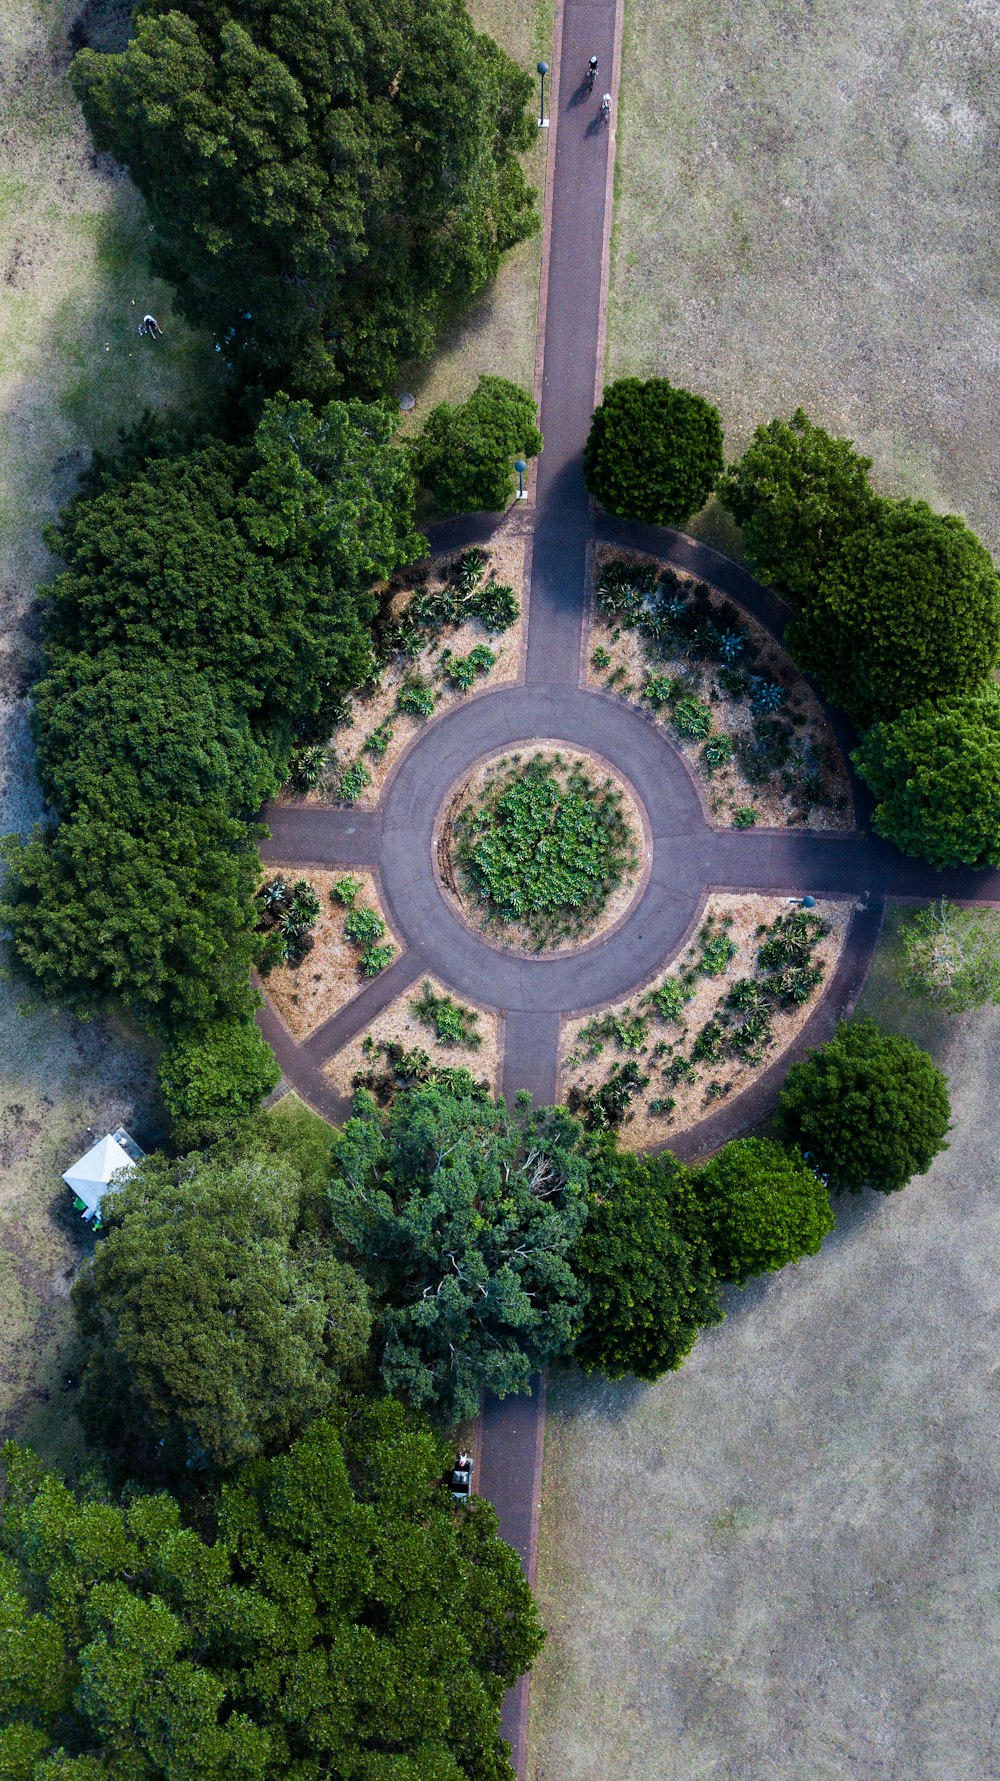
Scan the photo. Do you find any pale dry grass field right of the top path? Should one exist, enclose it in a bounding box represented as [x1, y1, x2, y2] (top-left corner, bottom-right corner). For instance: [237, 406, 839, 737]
[608, 0, 1000, 549]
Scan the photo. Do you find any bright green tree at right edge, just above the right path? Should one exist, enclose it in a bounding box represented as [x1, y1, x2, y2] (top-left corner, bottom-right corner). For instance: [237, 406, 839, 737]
[852, 682, 1000, 867]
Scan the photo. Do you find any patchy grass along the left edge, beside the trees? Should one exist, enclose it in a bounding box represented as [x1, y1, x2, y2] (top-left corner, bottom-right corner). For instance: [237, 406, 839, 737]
[0, 0, 214, 1468]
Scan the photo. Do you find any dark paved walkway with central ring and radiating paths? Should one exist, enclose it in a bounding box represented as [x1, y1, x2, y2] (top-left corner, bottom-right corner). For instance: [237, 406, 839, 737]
[260, 0, 1000, 1776]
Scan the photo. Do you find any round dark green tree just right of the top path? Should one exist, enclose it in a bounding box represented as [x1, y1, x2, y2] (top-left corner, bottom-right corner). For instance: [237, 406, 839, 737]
[583, 378, 724, 525]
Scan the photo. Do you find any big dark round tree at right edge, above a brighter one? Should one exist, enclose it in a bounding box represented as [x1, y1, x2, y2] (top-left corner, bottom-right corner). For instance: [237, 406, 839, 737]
[786, 500, 1000, 728]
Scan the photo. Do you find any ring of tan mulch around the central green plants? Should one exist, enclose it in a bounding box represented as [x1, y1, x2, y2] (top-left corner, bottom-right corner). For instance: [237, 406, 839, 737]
[435, 739, 641, 956]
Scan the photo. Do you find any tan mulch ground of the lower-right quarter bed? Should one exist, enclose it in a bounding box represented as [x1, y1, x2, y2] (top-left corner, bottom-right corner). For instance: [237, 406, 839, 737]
[560, 894, 844, 1151]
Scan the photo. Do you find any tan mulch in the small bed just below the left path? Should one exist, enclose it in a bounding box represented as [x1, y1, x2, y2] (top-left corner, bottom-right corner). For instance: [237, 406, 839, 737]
[262, 866, 405, 1038]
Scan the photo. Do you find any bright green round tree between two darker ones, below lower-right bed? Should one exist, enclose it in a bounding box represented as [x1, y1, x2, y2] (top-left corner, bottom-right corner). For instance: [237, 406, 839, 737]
[697, 1138, 834, 1284]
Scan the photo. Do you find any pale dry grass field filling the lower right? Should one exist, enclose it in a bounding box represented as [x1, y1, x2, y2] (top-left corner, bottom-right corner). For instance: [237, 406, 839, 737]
[529, 917, 1000, 1781]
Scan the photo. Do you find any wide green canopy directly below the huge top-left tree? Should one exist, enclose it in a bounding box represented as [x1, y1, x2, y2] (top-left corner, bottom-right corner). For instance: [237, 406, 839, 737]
[46, 395, 426, 737]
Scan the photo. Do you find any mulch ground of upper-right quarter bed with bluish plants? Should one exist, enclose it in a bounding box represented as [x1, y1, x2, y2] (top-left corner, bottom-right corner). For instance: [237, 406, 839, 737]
[586, 545, 854, 830]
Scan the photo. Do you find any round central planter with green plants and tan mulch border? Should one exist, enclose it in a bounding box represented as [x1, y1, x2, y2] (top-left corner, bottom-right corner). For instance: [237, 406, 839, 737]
[433, 739, 652, 958]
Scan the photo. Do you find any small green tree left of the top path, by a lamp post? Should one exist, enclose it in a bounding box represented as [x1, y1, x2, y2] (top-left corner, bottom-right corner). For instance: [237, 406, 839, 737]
[414, 378, 542, 513]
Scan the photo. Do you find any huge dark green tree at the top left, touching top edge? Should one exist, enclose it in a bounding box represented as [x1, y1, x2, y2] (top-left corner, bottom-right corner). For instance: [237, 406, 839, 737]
[73, 0, 537, 397]
